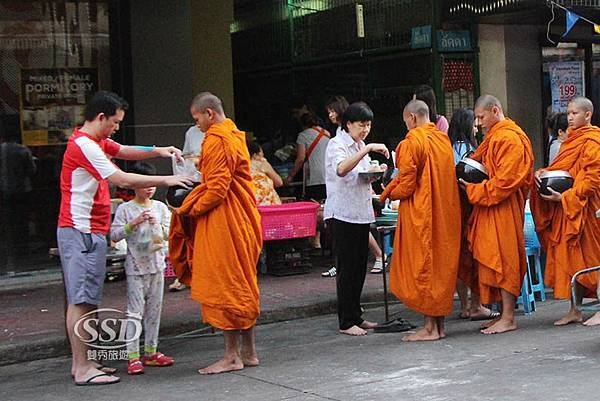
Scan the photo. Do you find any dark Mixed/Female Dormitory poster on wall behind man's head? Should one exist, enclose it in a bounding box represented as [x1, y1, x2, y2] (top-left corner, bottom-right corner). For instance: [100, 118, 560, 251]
[21, 68, 98, 146]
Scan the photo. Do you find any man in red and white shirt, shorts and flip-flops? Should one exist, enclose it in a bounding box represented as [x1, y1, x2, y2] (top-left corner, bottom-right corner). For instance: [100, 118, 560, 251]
[57, 91, 192, 385]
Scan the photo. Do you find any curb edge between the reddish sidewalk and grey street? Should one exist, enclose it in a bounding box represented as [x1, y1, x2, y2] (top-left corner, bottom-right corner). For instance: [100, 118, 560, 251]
[0, 290, 386, 366]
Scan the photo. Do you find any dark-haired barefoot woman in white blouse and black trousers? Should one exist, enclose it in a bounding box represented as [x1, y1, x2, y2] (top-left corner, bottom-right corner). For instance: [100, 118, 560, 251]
[323, 102, 389, 336]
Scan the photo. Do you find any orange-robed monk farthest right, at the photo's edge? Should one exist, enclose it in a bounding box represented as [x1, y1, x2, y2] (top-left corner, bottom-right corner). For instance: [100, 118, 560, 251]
[531, 97, 600, 326]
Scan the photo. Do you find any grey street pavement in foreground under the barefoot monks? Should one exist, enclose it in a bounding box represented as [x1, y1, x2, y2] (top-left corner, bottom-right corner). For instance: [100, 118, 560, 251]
[0, 300, 600, 401]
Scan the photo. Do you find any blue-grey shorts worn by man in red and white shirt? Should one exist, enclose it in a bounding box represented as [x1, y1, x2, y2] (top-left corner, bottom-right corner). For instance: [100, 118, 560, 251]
[56, 227, 106, 305]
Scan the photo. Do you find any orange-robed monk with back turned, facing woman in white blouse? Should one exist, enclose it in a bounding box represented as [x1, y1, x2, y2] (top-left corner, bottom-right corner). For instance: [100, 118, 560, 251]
[381, 100, 461, 341]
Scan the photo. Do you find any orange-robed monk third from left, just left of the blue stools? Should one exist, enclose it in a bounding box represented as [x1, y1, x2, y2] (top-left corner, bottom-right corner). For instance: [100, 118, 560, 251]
[459, 95, 533, 334]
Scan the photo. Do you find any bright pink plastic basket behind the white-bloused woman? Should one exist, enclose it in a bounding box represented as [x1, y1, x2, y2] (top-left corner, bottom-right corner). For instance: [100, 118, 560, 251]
[258, 202, 320, 241]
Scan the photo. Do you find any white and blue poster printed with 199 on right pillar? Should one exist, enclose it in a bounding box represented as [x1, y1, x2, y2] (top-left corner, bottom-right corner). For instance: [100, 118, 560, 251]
[548, 61, 585, 113]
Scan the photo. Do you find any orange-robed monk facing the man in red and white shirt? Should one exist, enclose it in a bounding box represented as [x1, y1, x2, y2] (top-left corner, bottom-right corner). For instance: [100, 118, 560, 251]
[173, 92, 262, 374]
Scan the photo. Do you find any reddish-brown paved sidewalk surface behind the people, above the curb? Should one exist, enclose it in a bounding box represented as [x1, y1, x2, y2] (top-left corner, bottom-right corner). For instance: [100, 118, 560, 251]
[0, 253, 383, 365]
